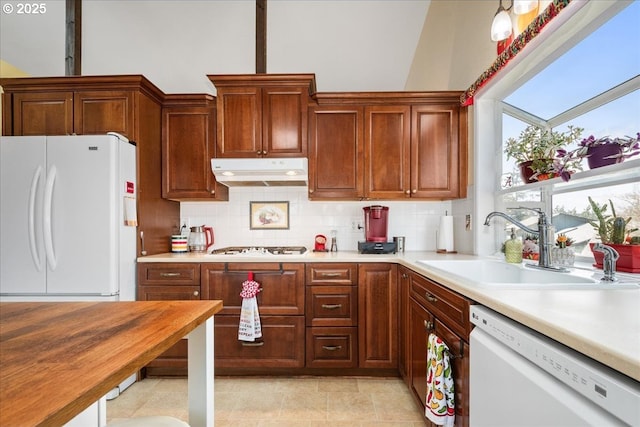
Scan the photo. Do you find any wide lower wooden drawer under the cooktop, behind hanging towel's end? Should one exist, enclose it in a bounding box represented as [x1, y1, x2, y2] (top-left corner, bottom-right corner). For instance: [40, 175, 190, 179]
[214, 315, 305, 368]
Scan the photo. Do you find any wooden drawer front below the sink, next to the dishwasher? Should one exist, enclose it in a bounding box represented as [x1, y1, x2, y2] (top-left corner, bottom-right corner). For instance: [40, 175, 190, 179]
[411, 275, 471, 340]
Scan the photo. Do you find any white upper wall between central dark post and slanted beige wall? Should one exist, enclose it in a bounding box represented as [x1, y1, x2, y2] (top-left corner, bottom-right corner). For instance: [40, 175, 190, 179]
[267, 0, 431, 92]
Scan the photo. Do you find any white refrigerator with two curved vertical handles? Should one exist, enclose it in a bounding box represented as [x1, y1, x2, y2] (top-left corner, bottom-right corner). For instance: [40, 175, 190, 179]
[0, 133, 137, 426]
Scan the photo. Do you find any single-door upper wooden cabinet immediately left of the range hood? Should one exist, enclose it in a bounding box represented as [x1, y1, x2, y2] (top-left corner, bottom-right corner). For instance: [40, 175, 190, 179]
[162, 94, 229, 201]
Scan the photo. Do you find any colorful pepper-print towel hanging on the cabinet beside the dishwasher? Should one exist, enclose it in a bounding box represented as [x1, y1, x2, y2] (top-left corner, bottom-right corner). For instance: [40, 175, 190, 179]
[425, 334, 456, 427]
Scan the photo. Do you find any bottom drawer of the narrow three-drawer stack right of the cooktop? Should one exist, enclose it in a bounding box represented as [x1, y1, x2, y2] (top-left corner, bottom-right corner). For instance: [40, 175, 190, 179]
[307, 327, 358, 368]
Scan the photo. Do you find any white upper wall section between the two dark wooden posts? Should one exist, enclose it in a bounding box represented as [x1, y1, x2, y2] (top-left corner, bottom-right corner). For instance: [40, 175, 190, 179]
[82, 0, 255, 93]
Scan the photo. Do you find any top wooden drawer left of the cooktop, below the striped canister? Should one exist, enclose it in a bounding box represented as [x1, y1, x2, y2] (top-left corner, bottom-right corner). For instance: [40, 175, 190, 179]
[138, 263, 200, 287]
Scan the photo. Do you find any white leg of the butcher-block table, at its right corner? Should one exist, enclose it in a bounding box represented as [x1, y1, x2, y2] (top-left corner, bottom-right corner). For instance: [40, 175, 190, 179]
[187, 317, 214, 427]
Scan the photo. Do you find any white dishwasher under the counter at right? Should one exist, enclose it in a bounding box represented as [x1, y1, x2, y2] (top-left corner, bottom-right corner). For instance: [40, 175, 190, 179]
[469, 305, 640, 427]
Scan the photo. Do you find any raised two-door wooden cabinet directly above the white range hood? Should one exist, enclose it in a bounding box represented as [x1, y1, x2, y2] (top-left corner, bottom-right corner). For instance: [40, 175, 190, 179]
[208, 74, 315, 158]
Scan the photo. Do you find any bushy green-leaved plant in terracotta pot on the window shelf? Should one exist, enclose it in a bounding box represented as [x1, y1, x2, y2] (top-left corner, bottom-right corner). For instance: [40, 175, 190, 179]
[504, 125, 584, 183]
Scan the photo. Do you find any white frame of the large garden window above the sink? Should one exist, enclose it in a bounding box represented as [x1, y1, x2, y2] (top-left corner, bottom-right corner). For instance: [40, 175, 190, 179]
[472, 1, 640, 255]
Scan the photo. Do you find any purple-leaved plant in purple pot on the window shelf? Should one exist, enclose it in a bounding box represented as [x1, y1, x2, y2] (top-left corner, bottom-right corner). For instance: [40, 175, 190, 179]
[558, 133, 640, 169]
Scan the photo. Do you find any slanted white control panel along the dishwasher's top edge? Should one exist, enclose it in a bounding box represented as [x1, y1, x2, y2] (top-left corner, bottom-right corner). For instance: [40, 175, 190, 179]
[470, 305, 640, 425]
